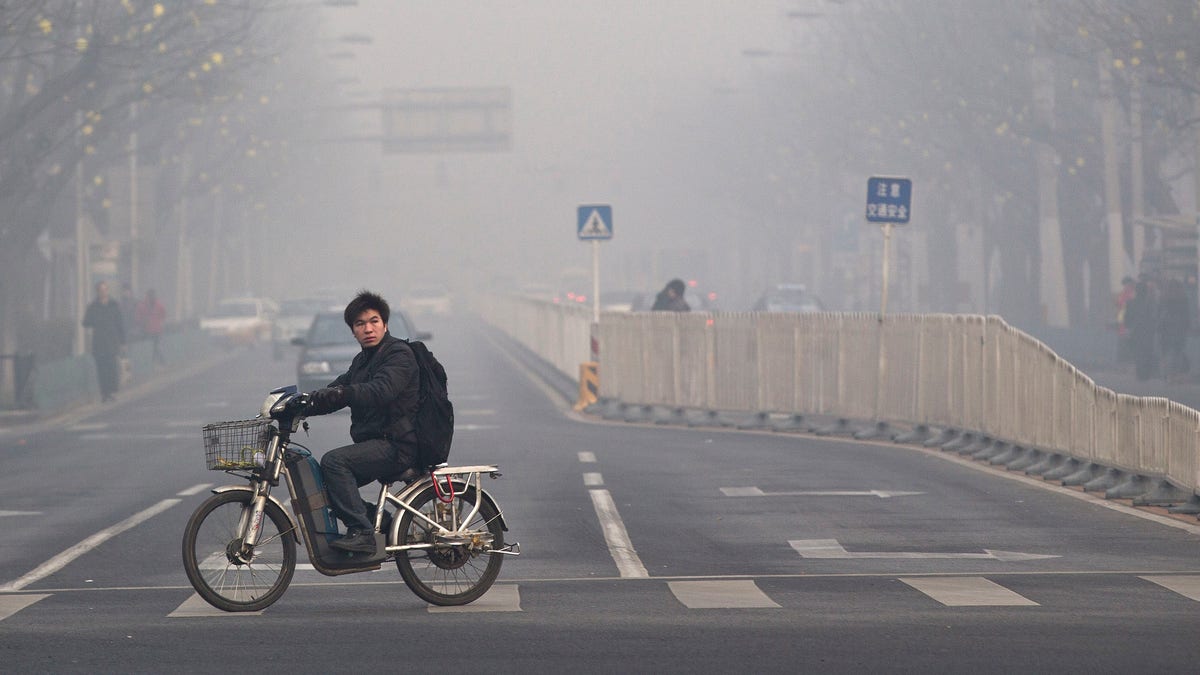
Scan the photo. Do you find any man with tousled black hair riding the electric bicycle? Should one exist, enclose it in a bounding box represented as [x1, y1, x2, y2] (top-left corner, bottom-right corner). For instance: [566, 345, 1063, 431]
[306, 291, 420, 554]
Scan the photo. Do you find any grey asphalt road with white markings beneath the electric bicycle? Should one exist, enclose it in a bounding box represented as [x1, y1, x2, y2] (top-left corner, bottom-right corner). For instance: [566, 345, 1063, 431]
[0, 318, 1200, 673]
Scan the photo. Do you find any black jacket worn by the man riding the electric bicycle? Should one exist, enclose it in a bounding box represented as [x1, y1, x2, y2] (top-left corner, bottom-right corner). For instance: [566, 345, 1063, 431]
[310, 333, 420, 446]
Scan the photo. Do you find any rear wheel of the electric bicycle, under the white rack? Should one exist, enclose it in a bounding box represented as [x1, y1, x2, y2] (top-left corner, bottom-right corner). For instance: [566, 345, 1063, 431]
[396, 483, 504, 605]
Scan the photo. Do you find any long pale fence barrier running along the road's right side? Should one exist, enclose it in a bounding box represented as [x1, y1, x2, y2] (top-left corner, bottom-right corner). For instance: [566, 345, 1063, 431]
[484, 298, 1200, 492]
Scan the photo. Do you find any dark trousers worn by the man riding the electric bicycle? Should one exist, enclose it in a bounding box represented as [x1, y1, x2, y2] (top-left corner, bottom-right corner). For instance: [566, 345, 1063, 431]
[320, 438, 414, 532]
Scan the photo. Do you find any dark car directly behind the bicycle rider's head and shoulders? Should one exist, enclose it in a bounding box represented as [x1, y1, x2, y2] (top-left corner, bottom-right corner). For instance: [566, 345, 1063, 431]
[293, 309, 433, 392]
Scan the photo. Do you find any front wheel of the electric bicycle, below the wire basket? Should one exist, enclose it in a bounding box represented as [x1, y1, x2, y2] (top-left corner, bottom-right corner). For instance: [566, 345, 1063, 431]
[184, 490, 296, 611]
